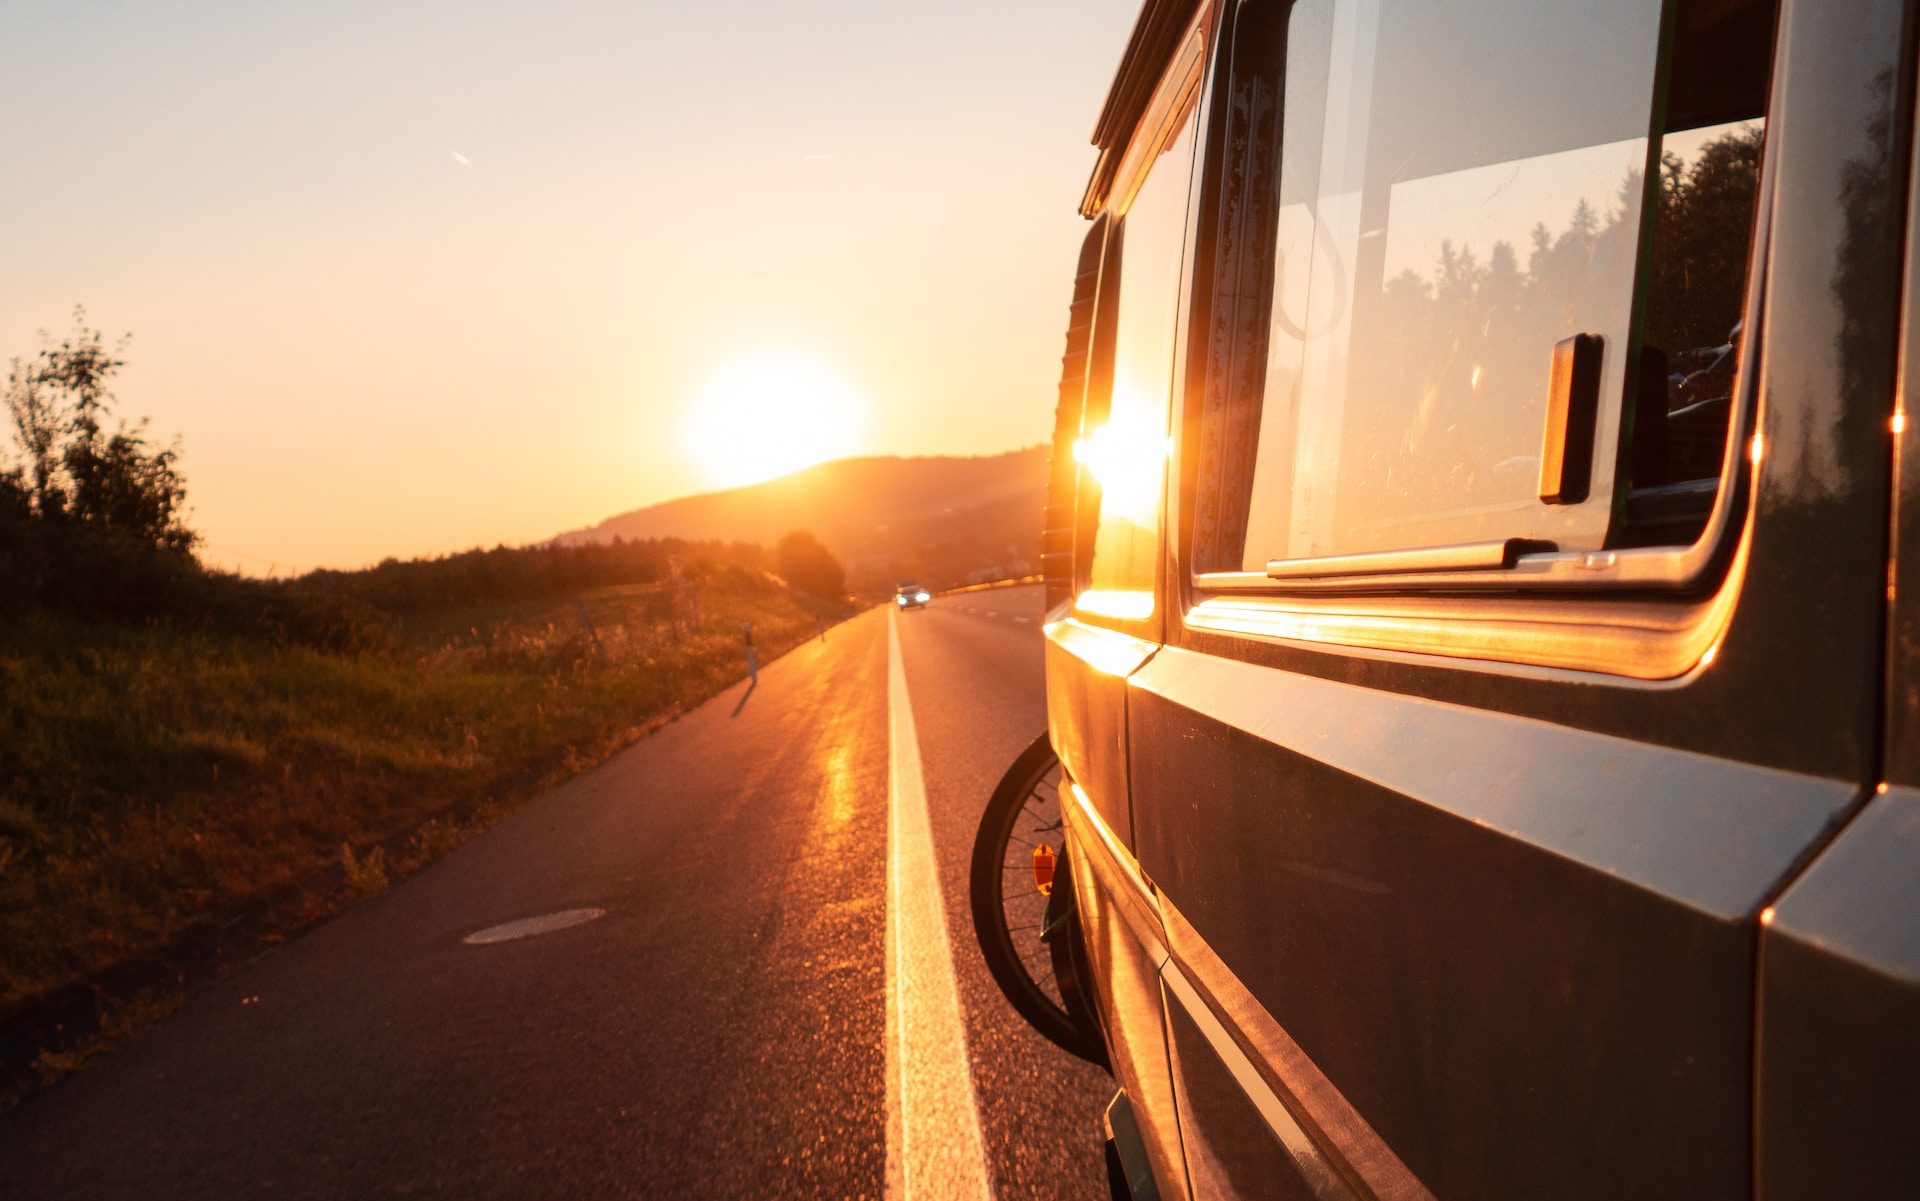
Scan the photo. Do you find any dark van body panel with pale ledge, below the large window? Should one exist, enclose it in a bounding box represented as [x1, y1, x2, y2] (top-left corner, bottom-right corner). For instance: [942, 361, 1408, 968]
[1129, 648, 1853, 1197]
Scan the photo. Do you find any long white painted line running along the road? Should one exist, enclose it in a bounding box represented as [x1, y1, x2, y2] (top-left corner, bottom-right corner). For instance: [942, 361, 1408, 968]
[887, 608, 993, 1201]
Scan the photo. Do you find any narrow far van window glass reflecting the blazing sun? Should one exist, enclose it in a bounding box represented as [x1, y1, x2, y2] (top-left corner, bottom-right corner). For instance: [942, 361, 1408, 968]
[1075, 104, 1194, 618]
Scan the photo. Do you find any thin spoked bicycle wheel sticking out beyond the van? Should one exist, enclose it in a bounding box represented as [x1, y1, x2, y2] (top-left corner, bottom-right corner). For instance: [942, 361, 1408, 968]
[968, 735, 1106, 1067]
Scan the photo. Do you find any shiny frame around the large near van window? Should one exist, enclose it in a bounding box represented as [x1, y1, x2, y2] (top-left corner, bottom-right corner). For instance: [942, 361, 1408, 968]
[1167, 0, 1782, 679]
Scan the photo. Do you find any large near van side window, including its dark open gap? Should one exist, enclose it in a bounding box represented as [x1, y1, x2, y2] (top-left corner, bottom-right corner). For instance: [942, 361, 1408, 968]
[1194, 0, 1772, 574]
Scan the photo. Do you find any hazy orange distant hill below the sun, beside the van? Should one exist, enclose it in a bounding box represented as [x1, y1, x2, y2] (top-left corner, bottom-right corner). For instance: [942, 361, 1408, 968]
[555, 445, 1046, 591]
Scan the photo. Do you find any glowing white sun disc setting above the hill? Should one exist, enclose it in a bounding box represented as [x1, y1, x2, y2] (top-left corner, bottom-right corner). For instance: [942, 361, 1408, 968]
[682, 351, 864, 487]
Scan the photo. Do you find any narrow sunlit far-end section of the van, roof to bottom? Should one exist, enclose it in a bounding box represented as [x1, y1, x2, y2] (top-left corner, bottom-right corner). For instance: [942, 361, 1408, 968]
[1044, 10, 1210, 1182]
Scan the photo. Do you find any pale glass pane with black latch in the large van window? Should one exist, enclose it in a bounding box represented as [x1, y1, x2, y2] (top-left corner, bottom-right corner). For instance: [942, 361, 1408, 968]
[1213, 0, 1661, 572]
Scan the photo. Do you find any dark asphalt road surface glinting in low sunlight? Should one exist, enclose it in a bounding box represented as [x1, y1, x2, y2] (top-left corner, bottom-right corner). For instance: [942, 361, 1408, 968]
[0, 587, 1112, 1201]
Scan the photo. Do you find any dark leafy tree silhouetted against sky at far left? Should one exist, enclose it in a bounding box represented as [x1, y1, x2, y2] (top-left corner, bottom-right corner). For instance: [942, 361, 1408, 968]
[0, 307, 194, 553]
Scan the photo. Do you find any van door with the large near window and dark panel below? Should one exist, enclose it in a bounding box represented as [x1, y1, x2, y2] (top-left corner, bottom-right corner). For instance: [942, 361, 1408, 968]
[1127, 0, 1910, 1199]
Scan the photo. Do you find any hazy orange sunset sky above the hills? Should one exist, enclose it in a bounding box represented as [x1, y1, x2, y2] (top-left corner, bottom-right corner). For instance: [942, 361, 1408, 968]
[0, 0, 1137, 574]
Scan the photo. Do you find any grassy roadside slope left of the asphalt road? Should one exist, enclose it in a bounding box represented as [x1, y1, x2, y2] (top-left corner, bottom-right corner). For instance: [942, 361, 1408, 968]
[0, 566, 840, 1036]
